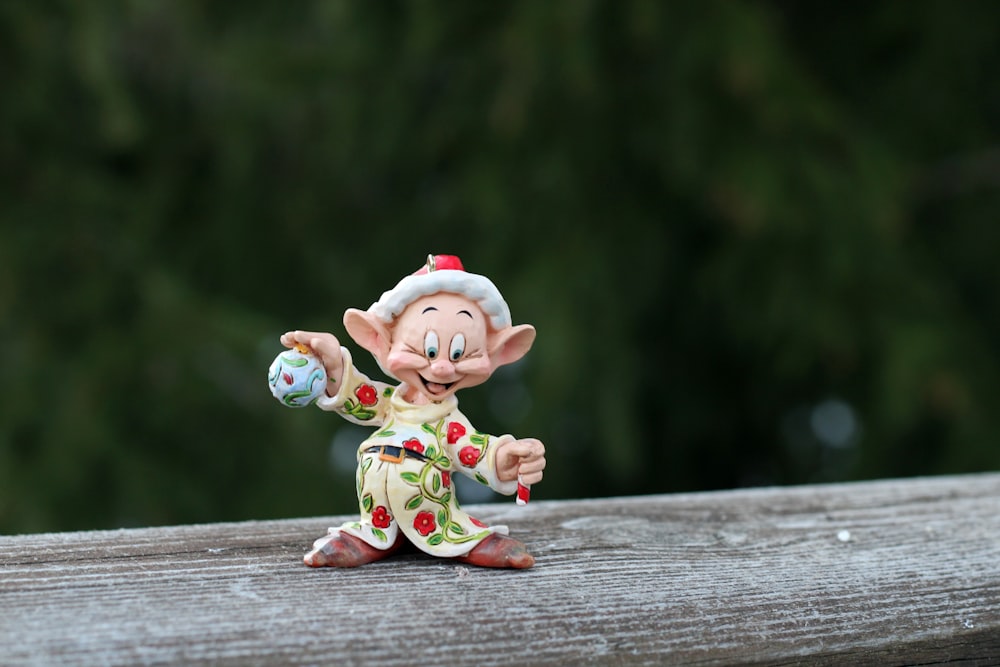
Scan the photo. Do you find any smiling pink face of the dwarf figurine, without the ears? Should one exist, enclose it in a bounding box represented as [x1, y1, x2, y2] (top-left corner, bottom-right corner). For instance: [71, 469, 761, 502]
[381, 292, 493, 401]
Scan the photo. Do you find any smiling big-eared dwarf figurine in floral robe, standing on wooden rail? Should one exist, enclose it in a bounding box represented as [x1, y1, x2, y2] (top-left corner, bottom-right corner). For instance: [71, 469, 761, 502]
[272, 255, 545, 568]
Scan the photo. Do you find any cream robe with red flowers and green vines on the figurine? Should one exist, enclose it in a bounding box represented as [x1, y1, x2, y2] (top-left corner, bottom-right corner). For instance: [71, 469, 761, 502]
[316, 347, 517, 557]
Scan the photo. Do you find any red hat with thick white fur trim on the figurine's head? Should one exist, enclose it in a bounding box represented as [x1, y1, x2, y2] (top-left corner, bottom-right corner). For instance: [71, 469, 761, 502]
[368, 255, 511, 330]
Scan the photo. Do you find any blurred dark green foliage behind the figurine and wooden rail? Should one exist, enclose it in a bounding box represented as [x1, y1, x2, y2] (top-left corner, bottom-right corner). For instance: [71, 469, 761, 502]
[0, 0, 1000, 532]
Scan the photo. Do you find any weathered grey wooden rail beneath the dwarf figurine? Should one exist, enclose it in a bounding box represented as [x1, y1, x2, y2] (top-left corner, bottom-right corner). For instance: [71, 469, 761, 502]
[0, 474, 1000, 666]
